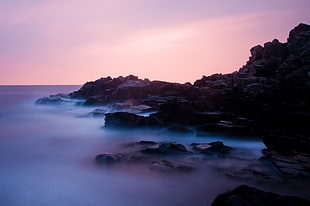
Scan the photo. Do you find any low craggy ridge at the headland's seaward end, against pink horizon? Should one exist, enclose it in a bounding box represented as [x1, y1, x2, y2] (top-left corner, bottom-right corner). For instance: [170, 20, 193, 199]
[70, 75, 195, 108]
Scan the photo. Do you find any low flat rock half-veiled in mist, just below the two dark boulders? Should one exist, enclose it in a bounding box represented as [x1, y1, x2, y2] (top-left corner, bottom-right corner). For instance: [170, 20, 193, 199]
[150, 160, 194, 172]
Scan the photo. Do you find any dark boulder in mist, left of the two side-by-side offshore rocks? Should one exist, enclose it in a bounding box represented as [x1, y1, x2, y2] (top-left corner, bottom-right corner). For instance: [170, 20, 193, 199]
[141, 142, 190, 155]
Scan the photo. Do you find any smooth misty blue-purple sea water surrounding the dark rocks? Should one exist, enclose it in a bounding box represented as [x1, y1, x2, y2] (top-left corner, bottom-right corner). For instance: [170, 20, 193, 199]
[0, 86, 308, 206]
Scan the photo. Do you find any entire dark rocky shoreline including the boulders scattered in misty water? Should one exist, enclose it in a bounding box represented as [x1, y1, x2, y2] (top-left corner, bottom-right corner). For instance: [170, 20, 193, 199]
[36, 24, 310, 205]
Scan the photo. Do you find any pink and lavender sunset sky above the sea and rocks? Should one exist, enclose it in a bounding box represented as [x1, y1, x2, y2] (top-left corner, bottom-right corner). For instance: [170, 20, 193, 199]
[0, 0, 310, 85]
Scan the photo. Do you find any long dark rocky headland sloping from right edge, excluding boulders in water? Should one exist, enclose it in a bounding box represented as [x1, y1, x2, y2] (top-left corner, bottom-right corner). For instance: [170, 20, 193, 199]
[36, 24, 310, 177]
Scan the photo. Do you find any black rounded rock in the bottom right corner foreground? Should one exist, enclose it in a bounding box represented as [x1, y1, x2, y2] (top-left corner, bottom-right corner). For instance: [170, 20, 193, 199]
[211, 185, 310, 206]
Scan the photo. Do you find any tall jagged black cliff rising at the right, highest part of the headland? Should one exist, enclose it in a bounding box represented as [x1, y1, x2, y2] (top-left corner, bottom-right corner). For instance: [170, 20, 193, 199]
[194, 24, 310, 133]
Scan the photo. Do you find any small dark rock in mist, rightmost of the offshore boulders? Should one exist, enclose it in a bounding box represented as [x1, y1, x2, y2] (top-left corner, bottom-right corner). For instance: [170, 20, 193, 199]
[191, 141, 232, 155]
